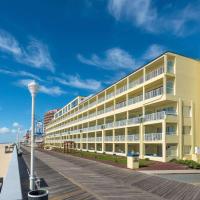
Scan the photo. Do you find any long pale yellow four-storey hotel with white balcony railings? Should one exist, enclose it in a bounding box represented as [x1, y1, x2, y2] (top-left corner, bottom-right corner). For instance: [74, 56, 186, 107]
[45, 52, 200, 162]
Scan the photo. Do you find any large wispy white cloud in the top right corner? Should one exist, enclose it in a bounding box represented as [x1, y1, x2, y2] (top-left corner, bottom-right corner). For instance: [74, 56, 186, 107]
[108, 0, 200, 36]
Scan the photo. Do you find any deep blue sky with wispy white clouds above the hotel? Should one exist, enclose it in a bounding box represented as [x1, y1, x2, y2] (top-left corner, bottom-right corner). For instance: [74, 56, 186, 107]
[0, 0, 200, 142]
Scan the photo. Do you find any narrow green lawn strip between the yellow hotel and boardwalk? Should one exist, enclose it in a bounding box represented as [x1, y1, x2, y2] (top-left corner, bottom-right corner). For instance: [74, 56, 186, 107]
[68, 151, 153, 167]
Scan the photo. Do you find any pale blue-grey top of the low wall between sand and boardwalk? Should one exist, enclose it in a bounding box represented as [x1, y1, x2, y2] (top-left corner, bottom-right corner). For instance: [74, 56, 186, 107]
[0, 147, 23, 200]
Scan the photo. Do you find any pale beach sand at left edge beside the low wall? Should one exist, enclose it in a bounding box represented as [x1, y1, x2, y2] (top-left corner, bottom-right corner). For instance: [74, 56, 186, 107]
[0, 144, 12, 177]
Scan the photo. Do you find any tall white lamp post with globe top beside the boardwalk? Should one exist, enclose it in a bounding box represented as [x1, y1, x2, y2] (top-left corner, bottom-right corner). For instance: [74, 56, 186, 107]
[28, 81, 39, 190]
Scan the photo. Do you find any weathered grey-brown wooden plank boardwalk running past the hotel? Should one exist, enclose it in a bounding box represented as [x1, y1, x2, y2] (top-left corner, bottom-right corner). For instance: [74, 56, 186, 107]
[20, 148, 200, 200]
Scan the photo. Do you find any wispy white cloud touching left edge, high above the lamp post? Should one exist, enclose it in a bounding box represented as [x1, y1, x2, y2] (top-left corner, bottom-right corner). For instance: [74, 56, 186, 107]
[0, 30, 55, 72]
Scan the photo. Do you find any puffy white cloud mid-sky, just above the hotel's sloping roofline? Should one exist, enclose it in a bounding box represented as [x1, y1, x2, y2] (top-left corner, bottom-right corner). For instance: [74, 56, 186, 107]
[77, 48, 135, 70]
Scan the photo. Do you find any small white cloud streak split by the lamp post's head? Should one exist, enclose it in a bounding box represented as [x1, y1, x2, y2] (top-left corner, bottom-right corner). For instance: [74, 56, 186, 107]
[17, 79, 66, 96]
